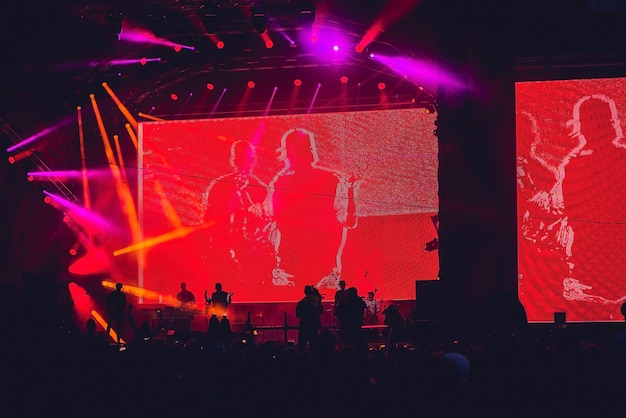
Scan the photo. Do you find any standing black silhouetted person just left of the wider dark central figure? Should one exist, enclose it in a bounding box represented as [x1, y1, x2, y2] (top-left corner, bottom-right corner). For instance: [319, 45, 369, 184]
[296, 285, 324, 351]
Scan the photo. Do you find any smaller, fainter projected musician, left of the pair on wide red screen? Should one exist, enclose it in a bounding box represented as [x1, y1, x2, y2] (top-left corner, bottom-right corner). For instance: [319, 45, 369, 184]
[201, 141, 277, 296]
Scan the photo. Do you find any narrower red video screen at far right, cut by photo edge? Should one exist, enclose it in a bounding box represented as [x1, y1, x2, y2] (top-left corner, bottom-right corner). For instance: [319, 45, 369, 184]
[515, 78, 626, 322]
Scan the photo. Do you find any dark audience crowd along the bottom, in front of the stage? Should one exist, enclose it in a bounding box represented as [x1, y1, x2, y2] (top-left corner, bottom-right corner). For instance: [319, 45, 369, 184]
[0, 300, 626, 417]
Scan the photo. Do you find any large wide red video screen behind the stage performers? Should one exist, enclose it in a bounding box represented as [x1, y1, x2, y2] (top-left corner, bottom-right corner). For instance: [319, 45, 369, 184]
[138, 109, 439, 302]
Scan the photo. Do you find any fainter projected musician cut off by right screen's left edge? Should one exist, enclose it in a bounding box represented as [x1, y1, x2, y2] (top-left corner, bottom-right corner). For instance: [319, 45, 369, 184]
[516, 111, 573, 317]
